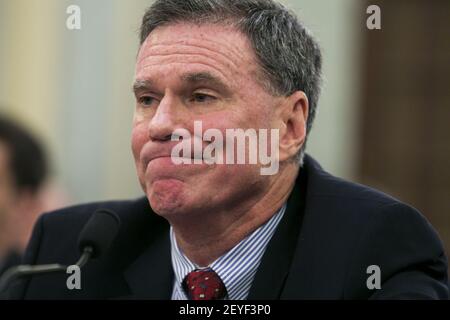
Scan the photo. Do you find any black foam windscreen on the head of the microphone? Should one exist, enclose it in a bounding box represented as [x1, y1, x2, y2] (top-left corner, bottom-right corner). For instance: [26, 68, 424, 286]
[78, 209, 121, 258]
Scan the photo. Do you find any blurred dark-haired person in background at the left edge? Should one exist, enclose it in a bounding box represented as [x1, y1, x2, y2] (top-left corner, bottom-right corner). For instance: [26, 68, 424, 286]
[0, 116, 47, 275]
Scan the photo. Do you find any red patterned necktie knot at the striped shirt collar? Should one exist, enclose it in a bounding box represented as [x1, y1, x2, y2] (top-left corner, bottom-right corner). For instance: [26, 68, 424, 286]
[183, 268, 227, 300]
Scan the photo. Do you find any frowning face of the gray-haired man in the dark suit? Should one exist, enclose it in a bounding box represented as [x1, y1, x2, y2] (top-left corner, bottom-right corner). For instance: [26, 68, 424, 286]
[132, 23, 280, 216]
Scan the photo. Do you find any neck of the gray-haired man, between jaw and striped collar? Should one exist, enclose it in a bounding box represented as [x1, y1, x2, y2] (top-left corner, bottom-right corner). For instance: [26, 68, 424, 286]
[170, 166, 298, 267]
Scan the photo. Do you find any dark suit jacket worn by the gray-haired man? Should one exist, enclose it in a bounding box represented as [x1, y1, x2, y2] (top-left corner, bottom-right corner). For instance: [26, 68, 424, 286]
[5, 156, 448, 299]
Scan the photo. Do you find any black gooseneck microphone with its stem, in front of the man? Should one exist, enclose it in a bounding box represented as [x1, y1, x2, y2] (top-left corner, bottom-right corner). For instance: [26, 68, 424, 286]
[0, 209, 121, 293]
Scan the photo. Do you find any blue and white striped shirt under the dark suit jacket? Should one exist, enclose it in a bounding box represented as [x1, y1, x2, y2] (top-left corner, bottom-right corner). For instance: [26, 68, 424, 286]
[170, 205, 286, 300]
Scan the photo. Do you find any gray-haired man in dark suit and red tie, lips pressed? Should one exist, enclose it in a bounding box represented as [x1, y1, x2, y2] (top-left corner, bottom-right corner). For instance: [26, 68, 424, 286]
[7, 0, 448, 300]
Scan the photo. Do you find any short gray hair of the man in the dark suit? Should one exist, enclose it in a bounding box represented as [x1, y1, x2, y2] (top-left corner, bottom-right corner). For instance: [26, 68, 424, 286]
[140, 0, 322, 164]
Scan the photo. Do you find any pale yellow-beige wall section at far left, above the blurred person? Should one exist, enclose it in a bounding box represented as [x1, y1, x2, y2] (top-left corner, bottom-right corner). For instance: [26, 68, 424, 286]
[0, 0, 60, 165]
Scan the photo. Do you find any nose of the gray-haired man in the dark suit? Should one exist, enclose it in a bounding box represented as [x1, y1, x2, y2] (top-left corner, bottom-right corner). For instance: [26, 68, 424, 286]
[148, 96, 181, 141]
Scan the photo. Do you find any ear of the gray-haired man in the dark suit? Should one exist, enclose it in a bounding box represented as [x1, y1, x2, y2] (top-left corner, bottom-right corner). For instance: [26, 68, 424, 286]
[280, 91, 309, 161]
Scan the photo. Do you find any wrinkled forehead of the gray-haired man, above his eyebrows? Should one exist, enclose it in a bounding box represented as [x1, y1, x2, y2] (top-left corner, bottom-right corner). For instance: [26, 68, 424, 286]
[136, 22, 258, 86]
